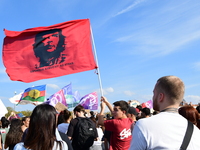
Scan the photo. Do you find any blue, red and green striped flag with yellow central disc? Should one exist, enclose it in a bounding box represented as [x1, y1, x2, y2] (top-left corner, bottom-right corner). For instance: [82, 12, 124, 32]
[19, 85, 46, 105]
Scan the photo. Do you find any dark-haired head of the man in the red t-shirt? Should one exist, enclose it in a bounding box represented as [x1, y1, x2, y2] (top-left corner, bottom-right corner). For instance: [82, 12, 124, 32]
[113, 100, 129, 119]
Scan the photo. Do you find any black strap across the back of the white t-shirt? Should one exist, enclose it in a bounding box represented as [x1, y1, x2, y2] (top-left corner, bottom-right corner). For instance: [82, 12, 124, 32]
[180, 121, 194, 150]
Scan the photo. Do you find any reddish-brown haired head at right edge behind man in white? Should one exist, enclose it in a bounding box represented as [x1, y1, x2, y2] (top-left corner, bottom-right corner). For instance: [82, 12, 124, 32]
[178, 105, 200, 125]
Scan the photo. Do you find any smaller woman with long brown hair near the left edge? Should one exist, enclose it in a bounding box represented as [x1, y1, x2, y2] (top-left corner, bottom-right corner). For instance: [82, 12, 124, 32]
[4, 119, 23, 150]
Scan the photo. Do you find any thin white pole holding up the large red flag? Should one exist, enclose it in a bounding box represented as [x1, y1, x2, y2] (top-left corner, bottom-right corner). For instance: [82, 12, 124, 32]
[90, 26, 103, 96]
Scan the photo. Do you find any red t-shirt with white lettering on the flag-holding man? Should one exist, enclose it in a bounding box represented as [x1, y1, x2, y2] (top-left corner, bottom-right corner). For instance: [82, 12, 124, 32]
[104, 118, 133, 150]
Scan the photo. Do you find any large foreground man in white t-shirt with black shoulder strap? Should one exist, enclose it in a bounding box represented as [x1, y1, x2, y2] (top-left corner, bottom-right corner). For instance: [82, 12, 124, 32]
[129, 76, 200, 150]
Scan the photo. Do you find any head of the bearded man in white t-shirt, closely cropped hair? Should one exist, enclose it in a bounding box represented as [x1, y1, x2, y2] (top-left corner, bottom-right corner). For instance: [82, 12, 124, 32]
[153, 76, 185, 111]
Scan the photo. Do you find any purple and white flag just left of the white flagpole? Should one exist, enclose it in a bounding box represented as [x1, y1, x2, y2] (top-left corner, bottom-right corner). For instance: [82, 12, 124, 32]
[79, 92, 98, 110]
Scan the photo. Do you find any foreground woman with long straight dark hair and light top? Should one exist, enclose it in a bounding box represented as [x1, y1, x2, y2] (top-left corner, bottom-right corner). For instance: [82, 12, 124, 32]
[14, 104, 68, 150]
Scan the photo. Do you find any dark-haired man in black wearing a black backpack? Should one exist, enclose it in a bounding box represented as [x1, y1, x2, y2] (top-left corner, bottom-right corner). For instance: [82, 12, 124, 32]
[67, 105, 98, 150]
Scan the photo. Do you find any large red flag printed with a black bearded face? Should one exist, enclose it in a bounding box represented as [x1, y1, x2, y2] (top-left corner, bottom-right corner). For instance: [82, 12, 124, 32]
[3, 19, 97, 82]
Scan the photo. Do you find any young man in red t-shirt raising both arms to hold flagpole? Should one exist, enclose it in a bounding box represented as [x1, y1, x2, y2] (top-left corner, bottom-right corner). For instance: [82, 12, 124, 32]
[98, 96, 133, 150]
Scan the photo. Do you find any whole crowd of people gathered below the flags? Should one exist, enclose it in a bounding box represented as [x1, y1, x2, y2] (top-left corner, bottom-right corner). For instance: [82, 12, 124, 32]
[0, 76, 200, 150]
